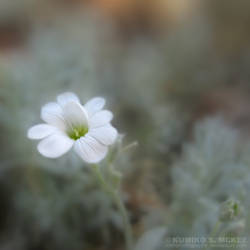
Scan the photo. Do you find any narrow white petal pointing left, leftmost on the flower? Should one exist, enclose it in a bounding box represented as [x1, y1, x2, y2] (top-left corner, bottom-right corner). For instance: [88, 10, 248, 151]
[27, 124, 57, 139]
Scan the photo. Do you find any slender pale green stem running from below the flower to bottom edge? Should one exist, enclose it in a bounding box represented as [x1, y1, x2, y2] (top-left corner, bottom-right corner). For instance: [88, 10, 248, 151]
[91, 165, 133, 250]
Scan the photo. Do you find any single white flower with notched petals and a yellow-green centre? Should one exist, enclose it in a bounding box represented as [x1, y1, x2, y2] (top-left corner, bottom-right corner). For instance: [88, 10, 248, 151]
[27, 92, 117, 163]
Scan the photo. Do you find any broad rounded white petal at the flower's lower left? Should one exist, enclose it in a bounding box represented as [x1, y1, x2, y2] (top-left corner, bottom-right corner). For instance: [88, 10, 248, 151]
[37, 133, 74, 158]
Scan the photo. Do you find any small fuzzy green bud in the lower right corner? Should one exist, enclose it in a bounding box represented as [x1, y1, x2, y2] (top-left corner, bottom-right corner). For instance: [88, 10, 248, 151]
[219, 199, 242, 222]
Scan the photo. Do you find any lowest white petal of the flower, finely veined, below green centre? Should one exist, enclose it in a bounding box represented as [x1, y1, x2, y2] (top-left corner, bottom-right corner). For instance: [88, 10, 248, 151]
[75, 135, 108, 163]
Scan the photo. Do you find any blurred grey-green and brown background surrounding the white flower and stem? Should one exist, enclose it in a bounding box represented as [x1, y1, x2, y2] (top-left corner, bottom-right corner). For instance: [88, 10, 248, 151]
[0, 0, 250, 250]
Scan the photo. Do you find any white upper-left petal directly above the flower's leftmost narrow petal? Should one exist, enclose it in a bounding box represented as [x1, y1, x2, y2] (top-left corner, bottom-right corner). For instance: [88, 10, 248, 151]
[41, 102, 66, 130]
